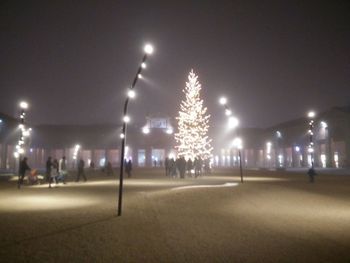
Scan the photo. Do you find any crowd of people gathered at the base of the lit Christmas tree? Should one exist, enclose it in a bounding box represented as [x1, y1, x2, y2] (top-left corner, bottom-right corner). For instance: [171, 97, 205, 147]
[165, 157, 210, 179]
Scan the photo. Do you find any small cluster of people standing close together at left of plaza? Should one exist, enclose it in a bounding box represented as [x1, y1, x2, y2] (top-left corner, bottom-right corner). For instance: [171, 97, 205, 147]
[46, 156, 68, 188]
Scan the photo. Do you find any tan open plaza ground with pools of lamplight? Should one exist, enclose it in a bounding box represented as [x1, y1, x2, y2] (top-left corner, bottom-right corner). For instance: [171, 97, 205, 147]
[0, 168, 350, 263]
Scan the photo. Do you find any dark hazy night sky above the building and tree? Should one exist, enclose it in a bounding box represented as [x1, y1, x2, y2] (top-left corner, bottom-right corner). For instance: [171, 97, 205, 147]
[0, 0, 350, 127]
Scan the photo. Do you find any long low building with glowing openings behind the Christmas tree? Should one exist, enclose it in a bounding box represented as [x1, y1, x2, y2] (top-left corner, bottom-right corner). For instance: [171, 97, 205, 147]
[0, 107, 350, 171]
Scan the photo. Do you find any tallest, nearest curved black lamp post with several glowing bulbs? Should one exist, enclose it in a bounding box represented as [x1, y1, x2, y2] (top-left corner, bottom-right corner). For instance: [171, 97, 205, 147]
[118, 44, 154, 216]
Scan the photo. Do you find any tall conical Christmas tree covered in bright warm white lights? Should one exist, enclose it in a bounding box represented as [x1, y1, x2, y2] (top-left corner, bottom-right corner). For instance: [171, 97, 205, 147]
[175, 70, 213, 160]
